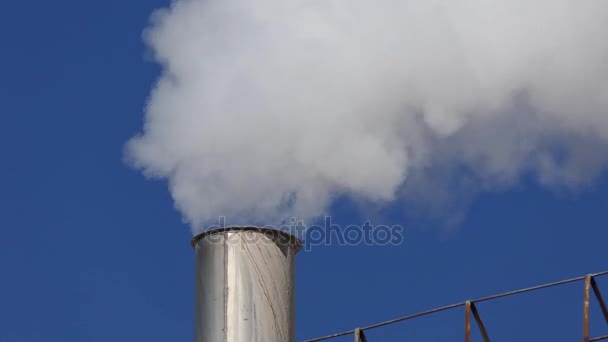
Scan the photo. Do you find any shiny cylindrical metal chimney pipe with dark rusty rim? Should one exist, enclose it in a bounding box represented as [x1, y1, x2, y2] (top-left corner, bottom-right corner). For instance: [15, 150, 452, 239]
[192, 227, 302, 342]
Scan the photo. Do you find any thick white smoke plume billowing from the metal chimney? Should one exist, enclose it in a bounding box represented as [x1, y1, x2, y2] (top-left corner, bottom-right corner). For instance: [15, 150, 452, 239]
[127, 0, 608, 231]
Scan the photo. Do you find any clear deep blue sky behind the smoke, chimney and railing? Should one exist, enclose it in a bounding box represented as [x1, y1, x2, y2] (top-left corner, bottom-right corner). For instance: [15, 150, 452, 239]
[0, 0, 608, 342]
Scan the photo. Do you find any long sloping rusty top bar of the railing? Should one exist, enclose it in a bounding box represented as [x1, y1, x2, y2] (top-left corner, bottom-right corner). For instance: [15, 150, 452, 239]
[304, 271, 608, 342]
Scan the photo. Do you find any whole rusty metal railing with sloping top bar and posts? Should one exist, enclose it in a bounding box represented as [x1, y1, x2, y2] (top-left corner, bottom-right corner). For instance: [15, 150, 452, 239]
[304, 271, 608, 342]
